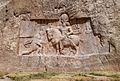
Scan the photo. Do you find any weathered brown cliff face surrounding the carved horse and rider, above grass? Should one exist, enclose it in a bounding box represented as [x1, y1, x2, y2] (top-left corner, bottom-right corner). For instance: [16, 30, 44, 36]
[0, 0, 120, 71]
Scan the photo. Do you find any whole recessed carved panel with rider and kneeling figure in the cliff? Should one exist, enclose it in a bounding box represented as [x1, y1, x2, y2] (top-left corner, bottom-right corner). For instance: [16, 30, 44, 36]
[19, 13, 109, 55]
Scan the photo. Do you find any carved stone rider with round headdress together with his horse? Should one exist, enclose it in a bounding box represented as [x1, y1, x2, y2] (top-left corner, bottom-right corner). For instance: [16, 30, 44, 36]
[46, 14, 80, 54]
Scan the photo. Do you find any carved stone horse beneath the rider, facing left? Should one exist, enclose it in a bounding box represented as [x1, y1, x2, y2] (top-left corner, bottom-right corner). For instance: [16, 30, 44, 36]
[46, 28, 80, 54]
